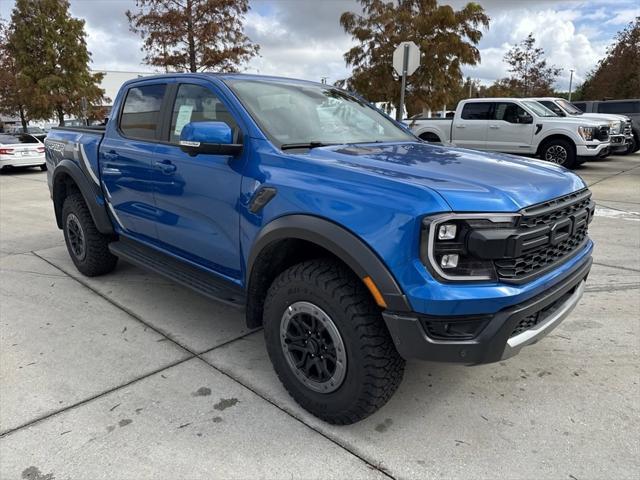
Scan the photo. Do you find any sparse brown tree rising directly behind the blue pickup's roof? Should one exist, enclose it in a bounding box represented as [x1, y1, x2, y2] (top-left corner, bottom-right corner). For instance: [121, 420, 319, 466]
[126, 0, 259, 72]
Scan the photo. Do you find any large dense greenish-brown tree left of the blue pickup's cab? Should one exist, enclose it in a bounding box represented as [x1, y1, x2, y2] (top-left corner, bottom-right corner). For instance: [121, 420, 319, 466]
[8, 0, 104, 125]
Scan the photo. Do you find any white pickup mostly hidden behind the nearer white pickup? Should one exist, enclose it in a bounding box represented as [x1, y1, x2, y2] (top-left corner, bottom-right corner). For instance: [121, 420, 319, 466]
[529, 97, 634, 154]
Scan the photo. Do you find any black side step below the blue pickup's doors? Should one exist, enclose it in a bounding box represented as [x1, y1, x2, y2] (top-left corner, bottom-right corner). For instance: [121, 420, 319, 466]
[109, 238, 245, 308]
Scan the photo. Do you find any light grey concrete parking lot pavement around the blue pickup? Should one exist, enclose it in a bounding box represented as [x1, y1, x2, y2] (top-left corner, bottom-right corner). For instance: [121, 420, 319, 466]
[0, 154, 640, 480]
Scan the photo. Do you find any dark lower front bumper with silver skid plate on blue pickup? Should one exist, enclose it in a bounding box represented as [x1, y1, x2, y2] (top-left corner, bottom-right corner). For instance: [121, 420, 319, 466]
[382, 256, 592, 365]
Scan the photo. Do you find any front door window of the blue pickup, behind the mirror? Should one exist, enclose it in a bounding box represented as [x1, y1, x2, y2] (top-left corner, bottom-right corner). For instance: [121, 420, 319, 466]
[169, 84, 238, 143]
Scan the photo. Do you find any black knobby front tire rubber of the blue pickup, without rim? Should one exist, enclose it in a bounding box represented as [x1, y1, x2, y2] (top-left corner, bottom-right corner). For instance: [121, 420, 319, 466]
[265, 259, 405, 425]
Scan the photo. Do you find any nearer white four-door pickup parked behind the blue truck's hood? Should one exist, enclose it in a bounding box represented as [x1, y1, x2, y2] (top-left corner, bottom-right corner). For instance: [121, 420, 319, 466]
[409, 98, 610, 168]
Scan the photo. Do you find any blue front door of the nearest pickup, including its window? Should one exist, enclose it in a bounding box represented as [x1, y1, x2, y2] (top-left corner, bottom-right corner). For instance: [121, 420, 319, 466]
[154, 81, 246, 279]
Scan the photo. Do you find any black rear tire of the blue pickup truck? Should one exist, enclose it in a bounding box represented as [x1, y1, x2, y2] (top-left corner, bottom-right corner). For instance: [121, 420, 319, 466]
[62, 193, 118, 277]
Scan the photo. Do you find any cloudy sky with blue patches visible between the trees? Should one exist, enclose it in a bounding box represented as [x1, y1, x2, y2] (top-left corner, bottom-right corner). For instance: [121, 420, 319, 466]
[0, 0, 640, 89]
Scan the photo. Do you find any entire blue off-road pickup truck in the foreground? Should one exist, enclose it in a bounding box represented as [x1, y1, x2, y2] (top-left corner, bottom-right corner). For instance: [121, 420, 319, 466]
[45, 74, 595, 424]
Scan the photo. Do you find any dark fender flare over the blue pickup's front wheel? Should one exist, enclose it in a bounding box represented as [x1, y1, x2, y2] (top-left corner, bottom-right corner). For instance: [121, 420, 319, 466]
[247, 214, 411, 312]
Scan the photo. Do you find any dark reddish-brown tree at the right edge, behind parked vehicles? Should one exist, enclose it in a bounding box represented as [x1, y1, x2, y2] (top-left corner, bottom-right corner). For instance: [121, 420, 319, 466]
[577, 17, 640, 100]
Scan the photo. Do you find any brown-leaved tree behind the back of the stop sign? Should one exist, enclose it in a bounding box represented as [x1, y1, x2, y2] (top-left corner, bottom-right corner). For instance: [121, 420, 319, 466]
[338, 0, 489, 114]
